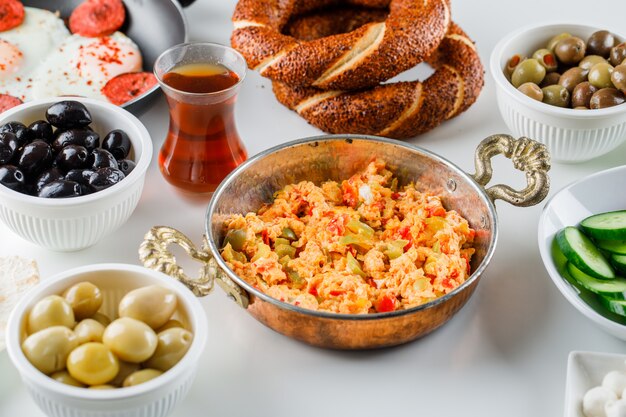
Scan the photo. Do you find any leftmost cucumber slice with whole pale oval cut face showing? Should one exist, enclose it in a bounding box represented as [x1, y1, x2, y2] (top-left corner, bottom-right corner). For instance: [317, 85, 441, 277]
[556, 226, 615, 279]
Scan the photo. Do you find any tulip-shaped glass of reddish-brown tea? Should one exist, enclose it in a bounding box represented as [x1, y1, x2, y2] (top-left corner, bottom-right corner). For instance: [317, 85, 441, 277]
[154, 43, 247, 195]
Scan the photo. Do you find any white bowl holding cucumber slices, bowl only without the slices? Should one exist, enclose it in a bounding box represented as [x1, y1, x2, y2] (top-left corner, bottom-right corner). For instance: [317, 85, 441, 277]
[538, 165, 626, 340]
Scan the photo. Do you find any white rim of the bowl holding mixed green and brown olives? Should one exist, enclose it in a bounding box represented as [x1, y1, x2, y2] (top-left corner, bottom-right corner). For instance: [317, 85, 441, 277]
[489, 21, 626, 119]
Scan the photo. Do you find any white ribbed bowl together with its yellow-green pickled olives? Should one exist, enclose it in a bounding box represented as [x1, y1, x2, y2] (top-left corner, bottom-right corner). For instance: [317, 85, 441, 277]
[7, 264, 207, 417]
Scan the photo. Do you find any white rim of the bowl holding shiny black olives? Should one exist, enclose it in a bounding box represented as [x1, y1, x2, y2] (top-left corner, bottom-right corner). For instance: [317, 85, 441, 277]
[0, 97, 152, 207]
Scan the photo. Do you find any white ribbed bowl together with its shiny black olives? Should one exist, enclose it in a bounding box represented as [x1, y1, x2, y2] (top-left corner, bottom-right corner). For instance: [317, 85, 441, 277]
[0, 97, 152, 251]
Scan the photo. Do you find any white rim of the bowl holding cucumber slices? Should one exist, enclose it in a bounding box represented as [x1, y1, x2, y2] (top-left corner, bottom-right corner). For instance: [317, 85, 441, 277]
[537, 165, 626, 332]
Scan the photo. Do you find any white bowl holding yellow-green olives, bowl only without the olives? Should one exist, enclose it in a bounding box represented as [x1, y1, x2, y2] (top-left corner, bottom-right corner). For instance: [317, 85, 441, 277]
[6, 264, 207, 417]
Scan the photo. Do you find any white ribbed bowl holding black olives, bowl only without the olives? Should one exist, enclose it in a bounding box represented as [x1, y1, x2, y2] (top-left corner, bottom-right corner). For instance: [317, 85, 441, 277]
[0, 97, 152, 251]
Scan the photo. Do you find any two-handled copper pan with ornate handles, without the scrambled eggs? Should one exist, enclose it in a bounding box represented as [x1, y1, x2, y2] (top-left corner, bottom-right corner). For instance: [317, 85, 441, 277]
[139, 135, 550, 349]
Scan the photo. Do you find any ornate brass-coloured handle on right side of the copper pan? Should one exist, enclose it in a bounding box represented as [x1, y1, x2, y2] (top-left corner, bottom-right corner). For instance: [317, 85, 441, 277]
[473, 135, 550, 207]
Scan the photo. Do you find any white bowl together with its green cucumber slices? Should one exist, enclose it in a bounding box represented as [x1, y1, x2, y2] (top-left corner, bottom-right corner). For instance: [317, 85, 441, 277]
[538, 165, 626, 340]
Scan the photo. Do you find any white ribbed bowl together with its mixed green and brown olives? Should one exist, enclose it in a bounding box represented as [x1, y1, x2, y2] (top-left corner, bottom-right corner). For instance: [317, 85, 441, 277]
[490, 23, 626, 163]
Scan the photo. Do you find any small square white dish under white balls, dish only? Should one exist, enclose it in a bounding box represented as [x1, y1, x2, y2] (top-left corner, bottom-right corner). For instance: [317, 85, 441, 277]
[565, 351, 626, 417]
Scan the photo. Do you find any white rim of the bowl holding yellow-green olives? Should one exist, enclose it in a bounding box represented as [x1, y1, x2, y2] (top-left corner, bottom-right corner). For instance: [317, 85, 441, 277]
[6, 264, 208, 402]
